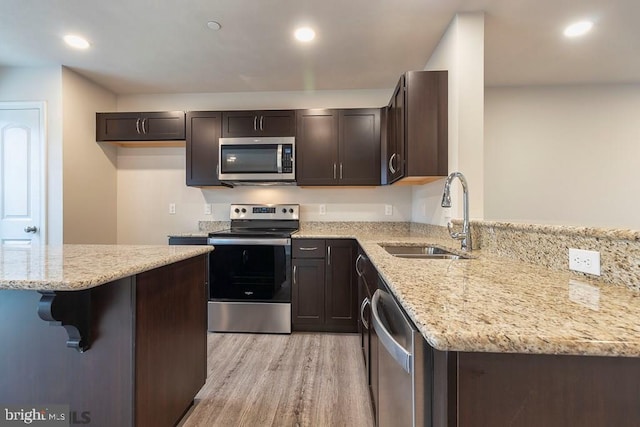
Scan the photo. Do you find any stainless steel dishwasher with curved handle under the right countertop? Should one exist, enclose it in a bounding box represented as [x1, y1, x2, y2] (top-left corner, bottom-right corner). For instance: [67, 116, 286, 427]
[371, 281, 433, 427]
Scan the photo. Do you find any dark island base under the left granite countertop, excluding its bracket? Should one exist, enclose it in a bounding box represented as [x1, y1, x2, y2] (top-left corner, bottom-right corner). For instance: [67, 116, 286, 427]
[0, 255, 206, 426]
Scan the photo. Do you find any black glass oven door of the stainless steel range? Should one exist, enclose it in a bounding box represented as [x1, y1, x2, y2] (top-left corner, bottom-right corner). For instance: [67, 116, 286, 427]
[209, 237, 291, 303]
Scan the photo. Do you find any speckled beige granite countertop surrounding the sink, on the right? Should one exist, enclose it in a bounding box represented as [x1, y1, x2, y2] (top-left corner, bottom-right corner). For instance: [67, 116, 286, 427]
[294, 226, 640, 357]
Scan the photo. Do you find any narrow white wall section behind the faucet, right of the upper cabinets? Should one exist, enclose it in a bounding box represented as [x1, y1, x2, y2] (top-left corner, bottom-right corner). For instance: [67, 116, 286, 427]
[411, 13, 484, 225]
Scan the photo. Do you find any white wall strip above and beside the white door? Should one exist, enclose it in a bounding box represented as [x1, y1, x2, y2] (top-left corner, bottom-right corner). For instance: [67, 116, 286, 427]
[0, 66, 63, 245]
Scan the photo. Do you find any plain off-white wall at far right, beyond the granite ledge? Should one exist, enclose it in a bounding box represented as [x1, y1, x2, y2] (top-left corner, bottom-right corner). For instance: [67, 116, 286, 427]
[485, 84, 640, 230]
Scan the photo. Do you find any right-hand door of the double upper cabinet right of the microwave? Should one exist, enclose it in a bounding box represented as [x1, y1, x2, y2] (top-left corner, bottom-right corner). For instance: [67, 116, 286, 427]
[338, 108, 381, 185]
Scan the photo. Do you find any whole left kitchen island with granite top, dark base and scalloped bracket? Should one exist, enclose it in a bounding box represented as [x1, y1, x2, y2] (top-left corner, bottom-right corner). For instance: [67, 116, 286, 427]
[0, 245, 212, 426]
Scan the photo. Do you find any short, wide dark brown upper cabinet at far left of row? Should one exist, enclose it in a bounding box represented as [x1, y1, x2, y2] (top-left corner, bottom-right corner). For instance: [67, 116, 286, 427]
[96, 111, 185, 141]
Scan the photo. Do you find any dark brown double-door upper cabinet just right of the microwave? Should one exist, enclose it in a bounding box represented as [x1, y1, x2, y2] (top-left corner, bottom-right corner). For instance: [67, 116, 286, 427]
[296, 108, 380, 186]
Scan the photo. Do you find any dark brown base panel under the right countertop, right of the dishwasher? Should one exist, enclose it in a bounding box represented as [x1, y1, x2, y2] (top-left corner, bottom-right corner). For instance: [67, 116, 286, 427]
[433, 351, 640, 427]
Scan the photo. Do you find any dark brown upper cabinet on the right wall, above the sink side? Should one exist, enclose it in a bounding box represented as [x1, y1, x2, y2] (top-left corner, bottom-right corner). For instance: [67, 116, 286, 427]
[383, 71, 449, 184]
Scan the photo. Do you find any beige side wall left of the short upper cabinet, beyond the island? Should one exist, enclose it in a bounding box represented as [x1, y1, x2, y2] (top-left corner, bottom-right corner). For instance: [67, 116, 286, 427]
[62, 68, 117, 244]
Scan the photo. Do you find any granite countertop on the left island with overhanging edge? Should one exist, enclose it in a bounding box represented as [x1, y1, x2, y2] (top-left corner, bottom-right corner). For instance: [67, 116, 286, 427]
[0, 245, 213, 291]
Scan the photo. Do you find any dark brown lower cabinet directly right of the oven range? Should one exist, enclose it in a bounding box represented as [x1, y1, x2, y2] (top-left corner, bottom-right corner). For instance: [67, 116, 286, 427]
[291, 239, 358, 332]
